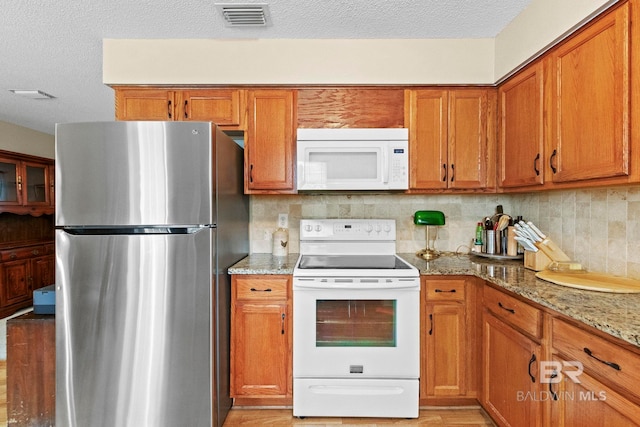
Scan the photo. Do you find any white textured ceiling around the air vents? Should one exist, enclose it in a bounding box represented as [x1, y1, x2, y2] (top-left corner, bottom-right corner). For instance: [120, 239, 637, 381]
[0, 0, 531, 134]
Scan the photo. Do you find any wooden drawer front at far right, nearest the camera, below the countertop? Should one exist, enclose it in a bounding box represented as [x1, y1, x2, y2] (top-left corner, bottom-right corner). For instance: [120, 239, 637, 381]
[552, 318, 640, 397]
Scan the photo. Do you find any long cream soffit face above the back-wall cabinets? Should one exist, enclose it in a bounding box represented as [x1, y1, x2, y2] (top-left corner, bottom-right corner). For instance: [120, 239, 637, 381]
[103, 39, 495, 84]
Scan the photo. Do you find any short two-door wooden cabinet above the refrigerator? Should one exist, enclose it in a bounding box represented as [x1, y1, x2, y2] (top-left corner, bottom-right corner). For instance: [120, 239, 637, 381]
[116, 88, 244, 130]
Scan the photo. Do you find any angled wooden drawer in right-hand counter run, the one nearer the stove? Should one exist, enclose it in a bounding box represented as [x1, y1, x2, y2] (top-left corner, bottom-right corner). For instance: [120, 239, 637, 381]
[484, 286, 542, 338]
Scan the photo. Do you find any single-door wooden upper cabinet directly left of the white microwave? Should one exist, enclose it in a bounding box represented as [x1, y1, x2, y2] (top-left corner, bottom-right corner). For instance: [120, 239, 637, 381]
[245, 90, 295, 193]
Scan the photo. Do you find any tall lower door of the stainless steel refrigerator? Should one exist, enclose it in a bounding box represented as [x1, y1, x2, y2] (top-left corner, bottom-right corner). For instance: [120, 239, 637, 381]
[56, 228, 215, 427]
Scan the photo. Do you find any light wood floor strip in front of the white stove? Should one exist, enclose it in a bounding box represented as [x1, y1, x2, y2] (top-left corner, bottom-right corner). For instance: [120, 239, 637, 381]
[224, 408, 495, 427]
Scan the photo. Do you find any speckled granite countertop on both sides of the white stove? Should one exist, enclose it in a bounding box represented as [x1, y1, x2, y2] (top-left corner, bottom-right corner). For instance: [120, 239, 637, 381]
[229, 253, 640, 347]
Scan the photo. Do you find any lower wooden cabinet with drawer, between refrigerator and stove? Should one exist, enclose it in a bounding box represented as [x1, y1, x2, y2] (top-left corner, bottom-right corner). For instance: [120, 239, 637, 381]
[231, 275, 293, 406]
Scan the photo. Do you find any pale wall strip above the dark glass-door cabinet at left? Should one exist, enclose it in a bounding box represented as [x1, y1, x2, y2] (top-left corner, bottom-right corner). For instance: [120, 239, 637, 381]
[0, 121, 55, 159]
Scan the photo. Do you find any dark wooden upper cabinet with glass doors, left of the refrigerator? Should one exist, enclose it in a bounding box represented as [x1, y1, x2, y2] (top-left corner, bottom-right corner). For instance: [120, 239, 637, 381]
[0, 151, 54, 216]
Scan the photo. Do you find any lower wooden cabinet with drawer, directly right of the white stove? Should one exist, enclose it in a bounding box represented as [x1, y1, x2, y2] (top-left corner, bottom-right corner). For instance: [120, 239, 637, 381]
[420, 276, 479, 405]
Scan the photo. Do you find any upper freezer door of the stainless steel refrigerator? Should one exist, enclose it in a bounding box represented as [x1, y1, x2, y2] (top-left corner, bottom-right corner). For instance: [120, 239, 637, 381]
[55, 122, 213, 227]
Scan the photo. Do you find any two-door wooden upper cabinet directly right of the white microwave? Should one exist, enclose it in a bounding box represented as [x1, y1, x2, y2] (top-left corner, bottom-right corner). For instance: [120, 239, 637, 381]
[405, 88, 496, 190]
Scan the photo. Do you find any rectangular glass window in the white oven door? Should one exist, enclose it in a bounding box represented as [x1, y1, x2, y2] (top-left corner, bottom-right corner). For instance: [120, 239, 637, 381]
[316, 300, 397, 347]
